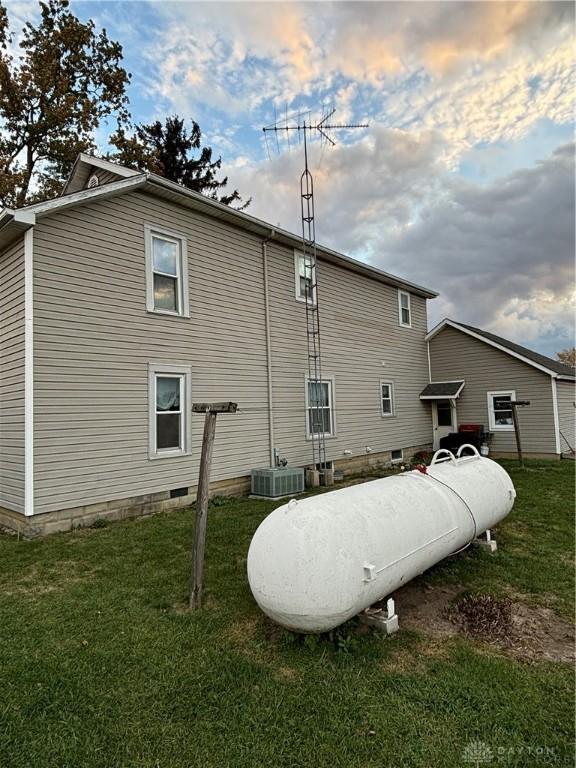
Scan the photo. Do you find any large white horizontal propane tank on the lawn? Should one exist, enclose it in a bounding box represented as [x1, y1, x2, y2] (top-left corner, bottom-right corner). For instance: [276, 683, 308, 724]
[248, 445, 516, 632]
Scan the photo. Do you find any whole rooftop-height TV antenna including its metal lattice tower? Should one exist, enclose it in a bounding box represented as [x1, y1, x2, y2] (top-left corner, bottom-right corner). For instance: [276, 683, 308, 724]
[262, 109, 368, 484]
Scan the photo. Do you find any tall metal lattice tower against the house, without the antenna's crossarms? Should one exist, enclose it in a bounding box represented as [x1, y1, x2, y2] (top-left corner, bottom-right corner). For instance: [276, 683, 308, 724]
[300, 123, 332, 477]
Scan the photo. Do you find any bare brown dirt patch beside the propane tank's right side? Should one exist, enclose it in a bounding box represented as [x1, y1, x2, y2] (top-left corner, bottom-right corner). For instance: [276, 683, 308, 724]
[395, 583, 575, 663]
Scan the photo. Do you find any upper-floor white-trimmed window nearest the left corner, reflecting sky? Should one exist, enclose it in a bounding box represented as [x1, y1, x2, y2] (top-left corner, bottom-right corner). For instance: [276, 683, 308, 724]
[145, 225, 189, 317]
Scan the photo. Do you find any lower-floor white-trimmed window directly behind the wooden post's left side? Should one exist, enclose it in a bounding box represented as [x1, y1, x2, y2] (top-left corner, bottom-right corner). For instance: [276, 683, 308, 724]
[149, 363, 191, 459]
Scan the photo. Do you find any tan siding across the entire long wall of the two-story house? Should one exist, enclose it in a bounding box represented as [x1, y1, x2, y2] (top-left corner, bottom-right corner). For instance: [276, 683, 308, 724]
[34, 193, 430, 512]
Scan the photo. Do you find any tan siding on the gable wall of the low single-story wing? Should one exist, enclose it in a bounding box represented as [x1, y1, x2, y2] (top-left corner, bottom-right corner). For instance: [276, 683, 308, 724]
[430, 327, 556, 453]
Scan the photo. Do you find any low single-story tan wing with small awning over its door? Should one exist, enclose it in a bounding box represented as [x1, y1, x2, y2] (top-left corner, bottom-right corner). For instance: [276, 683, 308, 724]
[423, 320, 576, 458]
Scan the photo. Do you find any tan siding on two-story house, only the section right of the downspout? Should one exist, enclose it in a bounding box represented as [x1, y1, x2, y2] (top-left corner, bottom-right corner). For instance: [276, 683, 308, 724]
[269, 238, 431, 464]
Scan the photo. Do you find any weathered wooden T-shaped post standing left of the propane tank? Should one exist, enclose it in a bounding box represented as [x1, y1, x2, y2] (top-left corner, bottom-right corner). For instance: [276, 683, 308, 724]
[189, 403, 238, 611]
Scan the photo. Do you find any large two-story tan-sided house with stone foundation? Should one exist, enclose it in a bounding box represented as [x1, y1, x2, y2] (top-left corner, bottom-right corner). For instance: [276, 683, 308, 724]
[0, 155, 436, 533]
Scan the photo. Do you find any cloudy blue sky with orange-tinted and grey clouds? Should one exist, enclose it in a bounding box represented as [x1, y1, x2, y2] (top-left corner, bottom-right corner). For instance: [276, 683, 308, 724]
[8, 0, 575, 355]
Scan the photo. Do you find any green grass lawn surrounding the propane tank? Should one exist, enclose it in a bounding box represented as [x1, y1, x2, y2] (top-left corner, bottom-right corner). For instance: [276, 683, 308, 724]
[0, 461, 574, 768]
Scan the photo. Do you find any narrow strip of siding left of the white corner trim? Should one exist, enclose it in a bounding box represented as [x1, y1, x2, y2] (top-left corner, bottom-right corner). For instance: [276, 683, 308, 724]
[0, 234, 24, 512]
